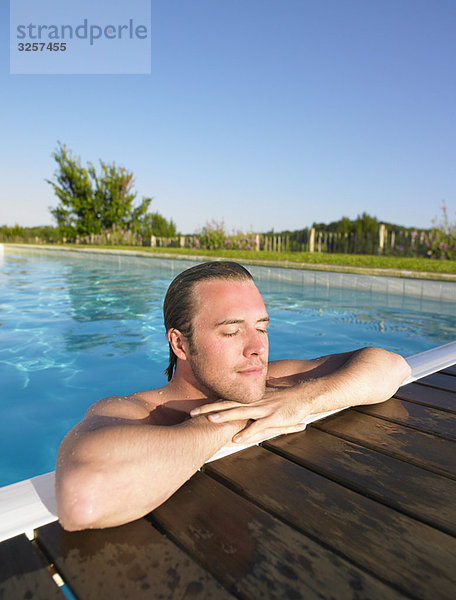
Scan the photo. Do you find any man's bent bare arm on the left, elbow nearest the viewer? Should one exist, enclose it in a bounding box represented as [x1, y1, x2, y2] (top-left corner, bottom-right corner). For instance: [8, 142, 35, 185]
[56, 398, 245, 531]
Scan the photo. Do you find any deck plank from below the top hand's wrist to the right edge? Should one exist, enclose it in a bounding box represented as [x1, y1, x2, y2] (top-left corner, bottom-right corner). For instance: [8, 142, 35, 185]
[263, 427, 456, 535]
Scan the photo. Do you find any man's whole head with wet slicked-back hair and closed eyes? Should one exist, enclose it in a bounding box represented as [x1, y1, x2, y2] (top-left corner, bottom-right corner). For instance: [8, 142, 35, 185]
[163, 262, 268, 401]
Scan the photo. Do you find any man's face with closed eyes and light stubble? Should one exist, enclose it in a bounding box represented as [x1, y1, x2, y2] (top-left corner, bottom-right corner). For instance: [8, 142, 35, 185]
[188, 279, 269, 403]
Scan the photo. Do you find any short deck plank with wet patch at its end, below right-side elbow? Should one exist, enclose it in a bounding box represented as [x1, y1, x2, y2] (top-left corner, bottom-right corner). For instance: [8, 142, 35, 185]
[355, 398, 456, 440]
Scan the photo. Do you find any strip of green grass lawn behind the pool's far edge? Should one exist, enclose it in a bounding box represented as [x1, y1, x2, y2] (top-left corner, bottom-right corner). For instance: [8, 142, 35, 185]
[19, 244, 456, 280]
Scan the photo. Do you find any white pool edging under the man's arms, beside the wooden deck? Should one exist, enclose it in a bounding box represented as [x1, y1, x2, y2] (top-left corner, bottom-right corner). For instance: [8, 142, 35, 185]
[0, 341, 456, 541]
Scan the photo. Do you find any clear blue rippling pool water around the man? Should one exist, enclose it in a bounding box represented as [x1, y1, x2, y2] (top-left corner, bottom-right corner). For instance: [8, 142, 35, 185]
[0, 248, 456, 485]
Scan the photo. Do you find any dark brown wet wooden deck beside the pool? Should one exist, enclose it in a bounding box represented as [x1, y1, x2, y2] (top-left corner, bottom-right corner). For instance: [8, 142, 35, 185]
[0, 366, 456, 600]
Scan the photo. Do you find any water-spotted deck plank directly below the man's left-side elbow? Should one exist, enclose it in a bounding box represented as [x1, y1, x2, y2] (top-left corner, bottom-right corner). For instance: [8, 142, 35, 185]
[37, 519, 233, 600]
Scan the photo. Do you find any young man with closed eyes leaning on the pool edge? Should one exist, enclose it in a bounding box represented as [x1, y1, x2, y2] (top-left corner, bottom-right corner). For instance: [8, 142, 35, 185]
[56, 262, 410, 530]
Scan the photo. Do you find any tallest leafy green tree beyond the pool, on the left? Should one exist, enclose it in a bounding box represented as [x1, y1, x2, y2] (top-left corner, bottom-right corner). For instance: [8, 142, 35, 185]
[46, 142, 152, 239]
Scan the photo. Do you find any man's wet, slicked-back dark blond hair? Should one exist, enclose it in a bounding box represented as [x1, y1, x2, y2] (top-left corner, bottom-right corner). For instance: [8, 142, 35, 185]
[163, 261, 253, 381]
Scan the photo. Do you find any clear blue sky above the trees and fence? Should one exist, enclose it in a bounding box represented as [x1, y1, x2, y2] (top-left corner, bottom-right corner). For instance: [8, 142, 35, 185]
[0, 0, 456, 233]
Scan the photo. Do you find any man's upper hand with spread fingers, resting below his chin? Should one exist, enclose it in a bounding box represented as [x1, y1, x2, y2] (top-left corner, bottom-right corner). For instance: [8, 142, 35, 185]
[190, 384, 309, 444]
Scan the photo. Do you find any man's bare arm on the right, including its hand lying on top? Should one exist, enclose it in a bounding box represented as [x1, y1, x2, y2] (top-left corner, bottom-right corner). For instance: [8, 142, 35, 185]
[190, 348, 410, 444]
